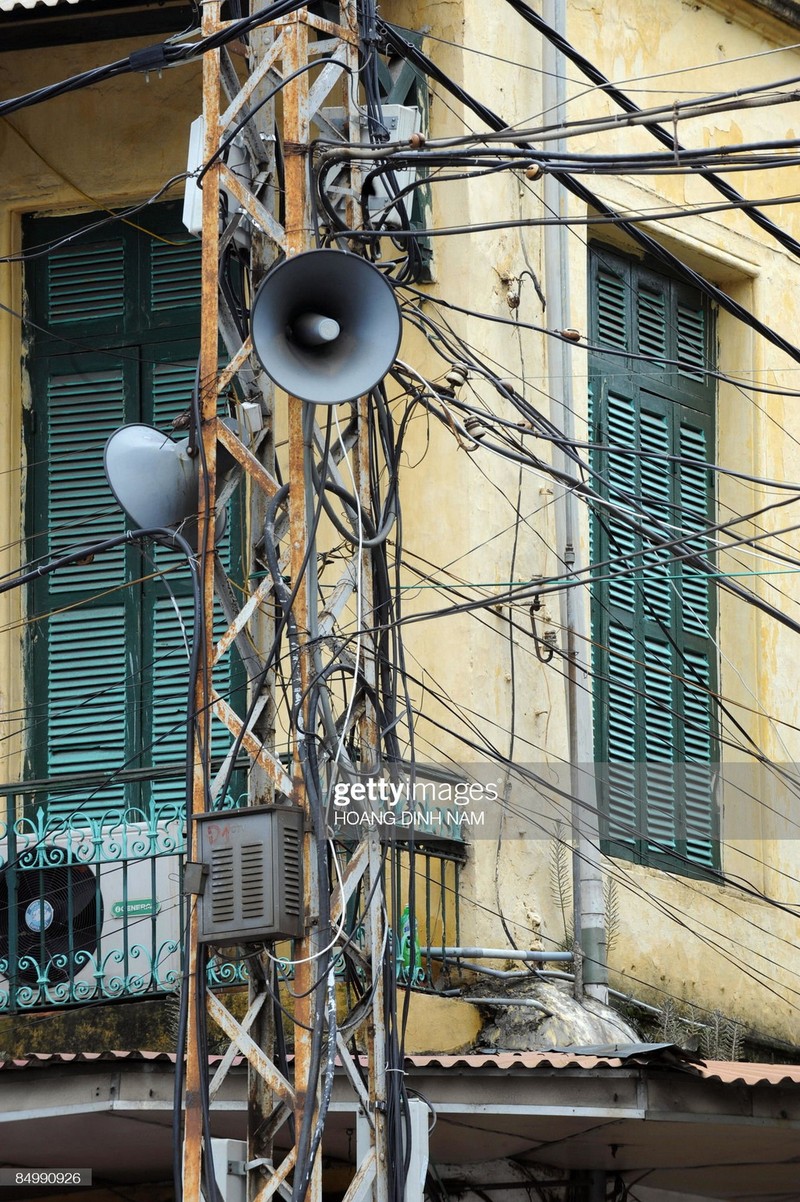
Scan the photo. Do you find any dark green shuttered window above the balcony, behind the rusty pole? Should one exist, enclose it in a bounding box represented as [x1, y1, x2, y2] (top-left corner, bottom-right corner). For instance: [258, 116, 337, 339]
[25, 206, 238, 814]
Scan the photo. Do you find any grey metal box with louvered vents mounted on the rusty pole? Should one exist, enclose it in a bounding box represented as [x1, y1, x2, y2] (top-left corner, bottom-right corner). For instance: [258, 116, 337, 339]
[196, 805, 305, 946]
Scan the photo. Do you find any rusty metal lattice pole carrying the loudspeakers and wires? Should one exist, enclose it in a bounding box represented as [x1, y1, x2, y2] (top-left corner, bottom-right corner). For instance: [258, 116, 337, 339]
[184, 0, 388, 1202]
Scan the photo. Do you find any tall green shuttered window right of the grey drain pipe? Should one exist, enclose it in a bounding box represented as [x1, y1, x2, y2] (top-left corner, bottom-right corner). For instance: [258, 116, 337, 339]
[589, 246, 718, 871]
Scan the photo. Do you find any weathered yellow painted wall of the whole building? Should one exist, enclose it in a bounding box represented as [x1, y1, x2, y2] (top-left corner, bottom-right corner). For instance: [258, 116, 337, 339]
[0, 0, 800, 1042]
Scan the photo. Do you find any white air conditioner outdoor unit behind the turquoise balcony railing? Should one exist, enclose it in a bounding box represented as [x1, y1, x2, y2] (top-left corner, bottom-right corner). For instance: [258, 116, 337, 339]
[0, 819, 183, 1013]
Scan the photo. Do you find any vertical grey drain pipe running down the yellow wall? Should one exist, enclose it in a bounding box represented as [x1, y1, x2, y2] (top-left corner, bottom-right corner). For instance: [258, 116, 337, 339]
[542, 0, 608, 1002]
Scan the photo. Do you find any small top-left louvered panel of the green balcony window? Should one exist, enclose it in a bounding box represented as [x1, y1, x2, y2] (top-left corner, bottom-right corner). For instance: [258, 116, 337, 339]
[46, 242, 125, 325]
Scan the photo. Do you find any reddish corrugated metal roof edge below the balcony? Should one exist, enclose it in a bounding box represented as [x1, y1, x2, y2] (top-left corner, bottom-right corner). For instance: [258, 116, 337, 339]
[0, 1048, 800, 1085]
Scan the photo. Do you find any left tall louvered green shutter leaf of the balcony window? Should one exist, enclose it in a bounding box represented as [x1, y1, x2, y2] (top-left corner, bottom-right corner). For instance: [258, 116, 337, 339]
[29, 350, 133, 810]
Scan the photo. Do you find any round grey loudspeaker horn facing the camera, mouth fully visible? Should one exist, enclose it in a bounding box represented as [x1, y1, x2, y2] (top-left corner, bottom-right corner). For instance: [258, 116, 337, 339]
[250, 250, 401, 405]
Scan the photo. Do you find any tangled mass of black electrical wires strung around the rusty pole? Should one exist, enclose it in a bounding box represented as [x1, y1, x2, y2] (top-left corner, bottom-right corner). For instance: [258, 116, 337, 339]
[7, 0, 800, 1202]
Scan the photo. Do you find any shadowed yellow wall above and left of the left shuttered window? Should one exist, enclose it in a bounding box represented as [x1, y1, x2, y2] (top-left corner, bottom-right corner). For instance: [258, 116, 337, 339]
[0, 41, 202, 781]
